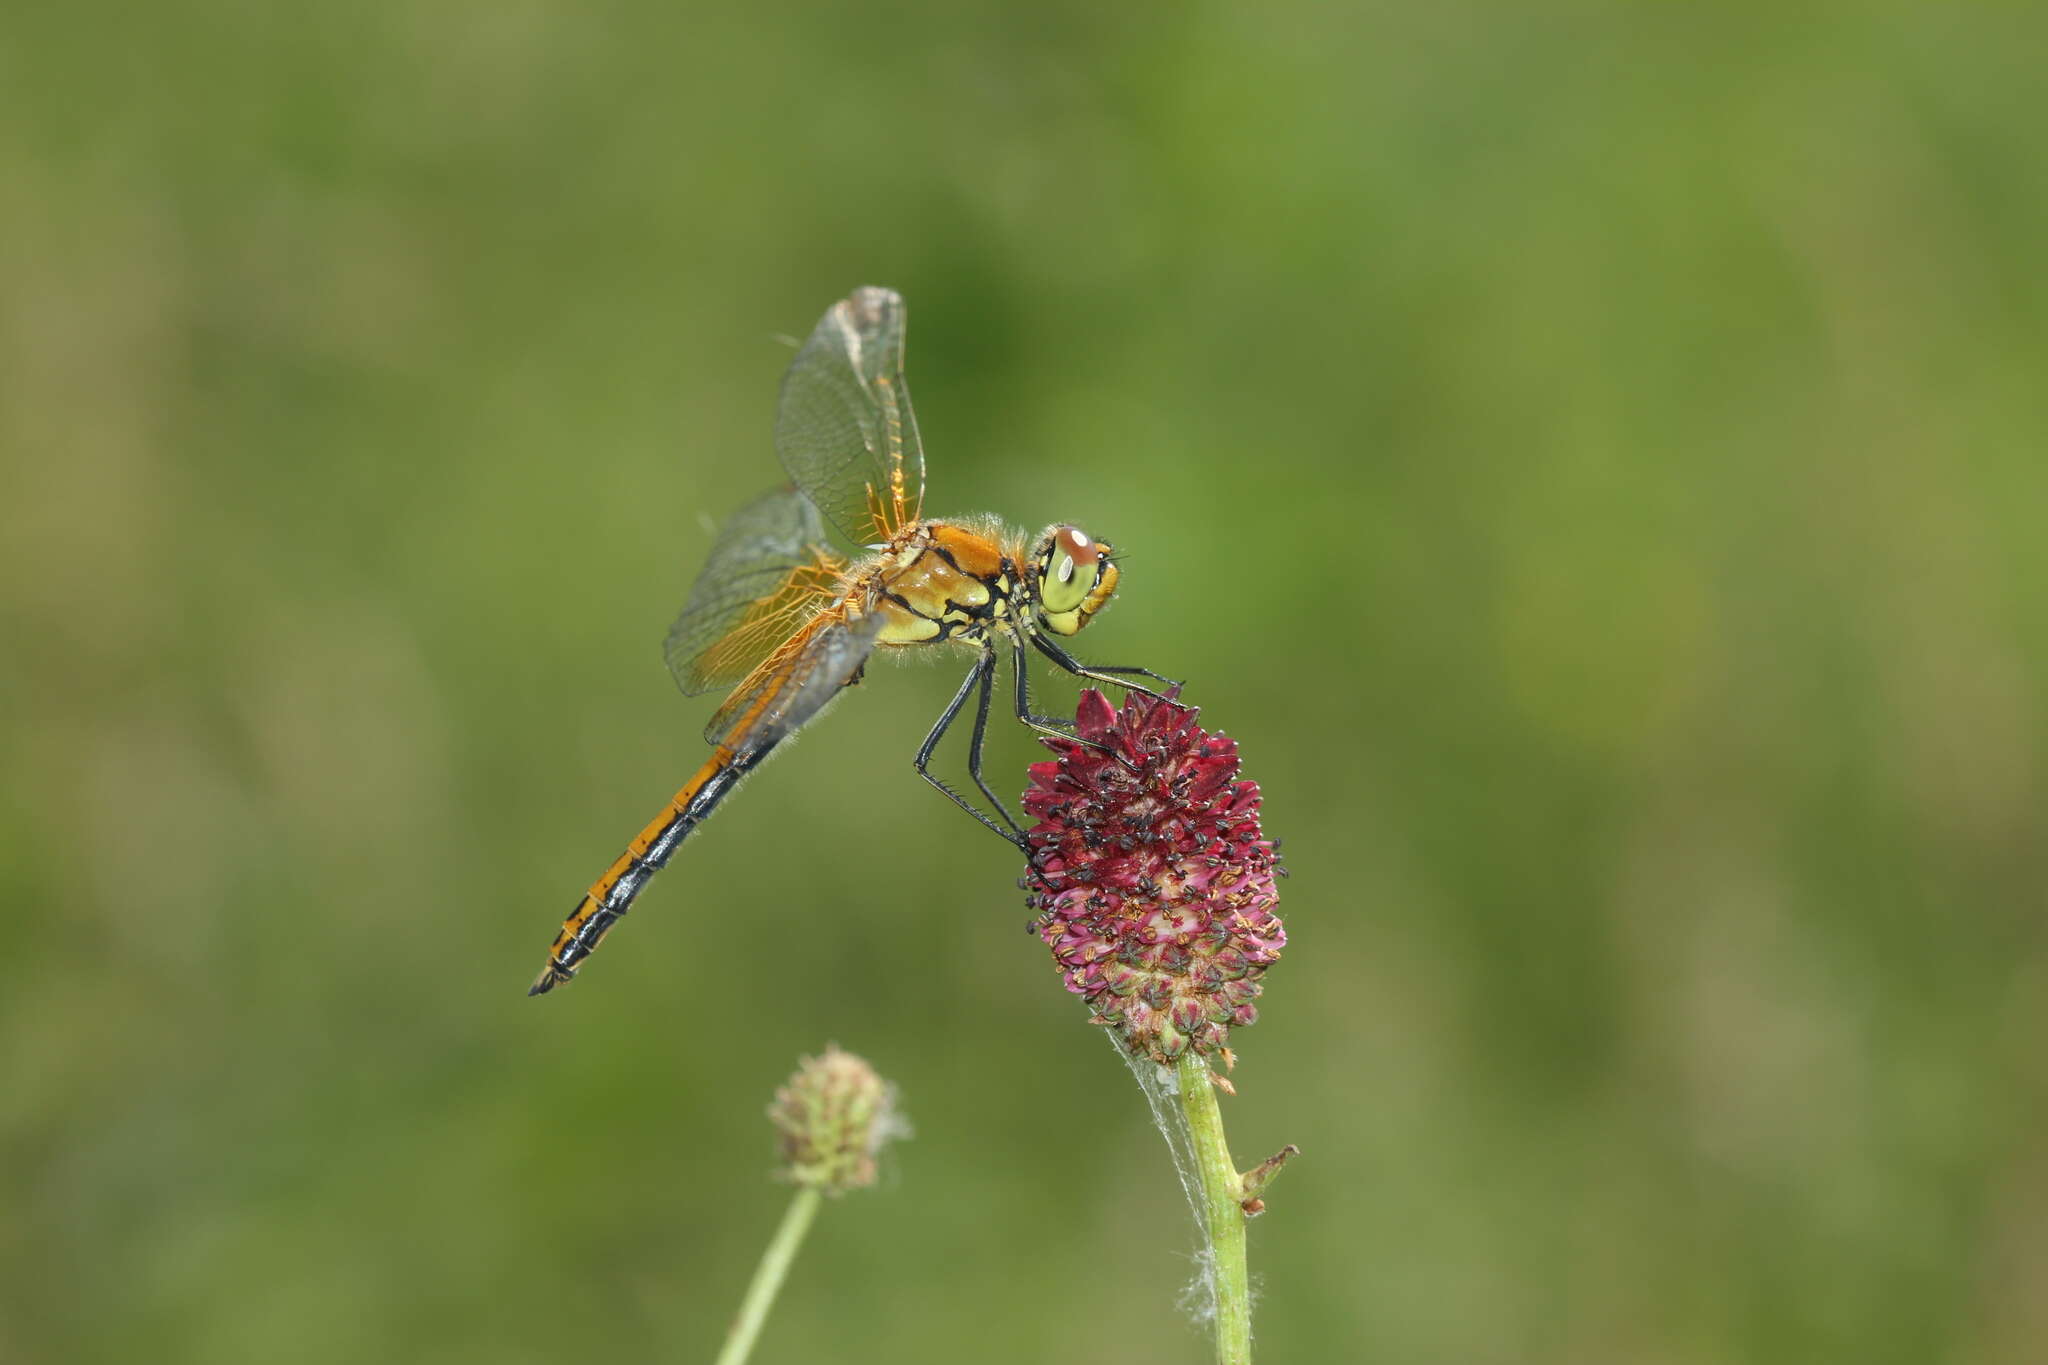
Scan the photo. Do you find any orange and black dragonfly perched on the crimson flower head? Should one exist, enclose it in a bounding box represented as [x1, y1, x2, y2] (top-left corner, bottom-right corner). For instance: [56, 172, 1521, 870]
[528, 287, 1171, 995]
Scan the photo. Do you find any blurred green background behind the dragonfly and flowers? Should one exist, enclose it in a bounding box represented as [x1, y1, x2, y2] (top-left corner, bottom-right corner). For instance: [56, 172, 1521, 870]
[0, 0, 2048, 1363]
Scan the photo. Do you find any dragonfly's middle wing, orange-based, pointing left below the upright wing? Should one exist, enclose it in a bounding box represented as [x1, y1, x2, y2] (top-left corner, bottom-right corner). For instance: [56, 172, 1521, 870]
[662, 489, 846, 696]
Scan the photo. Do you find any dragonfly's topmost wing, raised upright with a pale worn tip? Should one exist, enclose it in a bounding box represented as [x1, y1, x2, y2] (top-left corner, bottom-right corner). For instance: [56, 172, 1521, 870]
[774, 287, 924, 544]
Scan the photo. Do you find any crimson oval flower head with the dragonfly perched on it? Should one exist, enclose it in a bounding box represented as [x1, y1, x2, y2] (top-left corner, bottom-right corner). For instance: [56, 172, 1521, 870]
[1022, 690, 1286, 1062]
